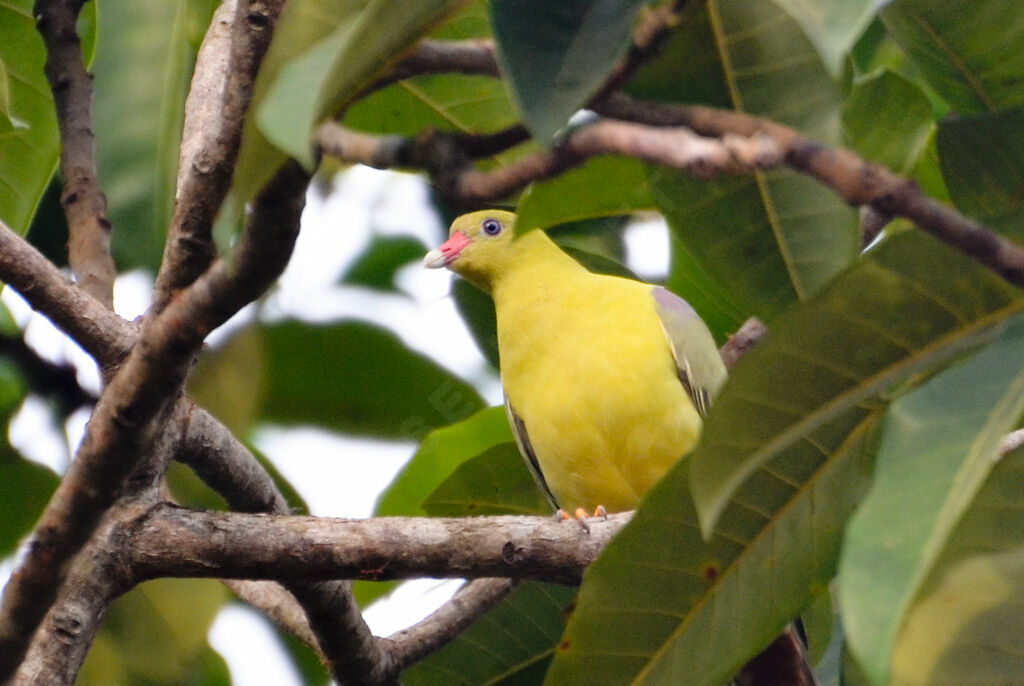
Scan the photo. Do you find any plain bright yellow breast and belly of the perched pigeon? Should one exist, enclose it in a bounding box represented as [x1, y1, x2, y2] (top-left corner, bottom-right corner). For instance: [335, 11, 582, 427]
[493, 268, 701, 512]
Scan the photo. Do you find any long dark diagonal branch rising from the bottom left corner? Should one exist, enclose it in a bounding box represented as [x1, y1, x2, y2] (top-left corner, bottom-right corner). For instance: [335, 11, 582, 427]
[0, 165, 308, 680]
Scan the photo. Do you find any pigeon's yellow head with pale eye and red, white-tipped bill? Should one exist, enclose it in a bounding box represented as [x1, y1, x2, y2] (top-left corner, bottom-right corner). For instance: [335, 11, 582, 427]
[423, 210, 516, 293]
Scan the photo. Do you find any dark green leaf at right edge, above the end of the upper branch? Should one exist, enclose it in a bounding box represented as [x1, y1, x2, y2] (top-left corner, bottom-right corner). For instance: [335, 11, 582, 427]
[936, 108, 1024, 241]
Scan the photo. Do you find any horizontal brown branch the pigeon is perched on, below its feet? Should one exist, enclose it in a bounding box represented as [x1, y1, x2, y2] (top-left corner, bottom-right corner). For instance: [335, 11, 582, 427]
[127, 505, 629, 585]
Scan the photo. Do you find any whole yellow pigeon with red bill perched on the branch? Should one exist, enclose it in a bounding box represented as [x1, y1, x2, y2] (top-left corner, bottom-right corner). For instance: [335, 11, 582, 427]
[424, 210, 726, 512]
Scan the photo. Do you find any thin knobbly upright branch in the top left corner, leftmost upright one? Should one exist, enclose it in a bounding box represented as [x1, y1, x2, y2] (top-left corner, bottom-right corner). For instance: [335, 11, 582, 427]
[34, 0, 117, 308]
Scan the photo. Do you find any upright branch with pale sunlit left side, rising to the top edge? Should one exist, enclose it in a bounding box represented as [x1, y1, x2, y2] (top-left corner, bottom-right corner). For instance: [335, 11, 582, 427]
[151, 0, 284, 313]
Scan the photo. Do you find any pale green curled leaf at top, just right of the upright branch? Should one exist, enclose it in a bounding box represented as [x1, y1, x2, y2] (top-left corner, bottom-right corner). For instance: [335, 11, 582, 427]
[256, 0, 464, 168]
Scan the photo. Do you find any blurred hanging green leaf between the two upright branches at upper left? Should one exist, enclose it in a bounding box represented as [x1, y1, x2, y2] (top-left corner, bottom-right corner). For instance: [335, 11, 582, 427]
[87, 0, 212, 270]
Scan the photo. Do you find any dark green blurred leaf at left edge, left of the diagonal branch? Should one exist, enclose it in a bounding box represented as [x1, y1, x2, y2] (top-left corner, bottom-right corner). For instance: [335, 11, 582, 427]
[0, 446, 60, 559]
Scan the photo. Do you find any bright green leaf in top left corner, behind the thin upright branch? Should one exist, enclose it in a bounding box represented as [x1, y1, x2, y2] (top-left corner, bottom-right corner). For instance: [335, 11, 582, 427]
[0, 0, 96, 233]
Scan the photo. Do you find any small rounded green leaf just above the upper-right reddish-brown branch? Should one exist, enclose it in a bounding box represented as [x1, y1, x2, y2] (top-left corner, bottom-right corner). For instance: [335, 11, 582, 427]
[843, 71, 935, 175]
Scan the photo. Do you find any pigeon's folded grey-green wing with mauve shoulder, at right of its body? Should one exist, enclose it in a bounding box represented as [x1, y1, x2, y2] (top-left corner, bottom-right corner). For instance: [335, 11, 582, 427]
[651, 286, 726, 417]
